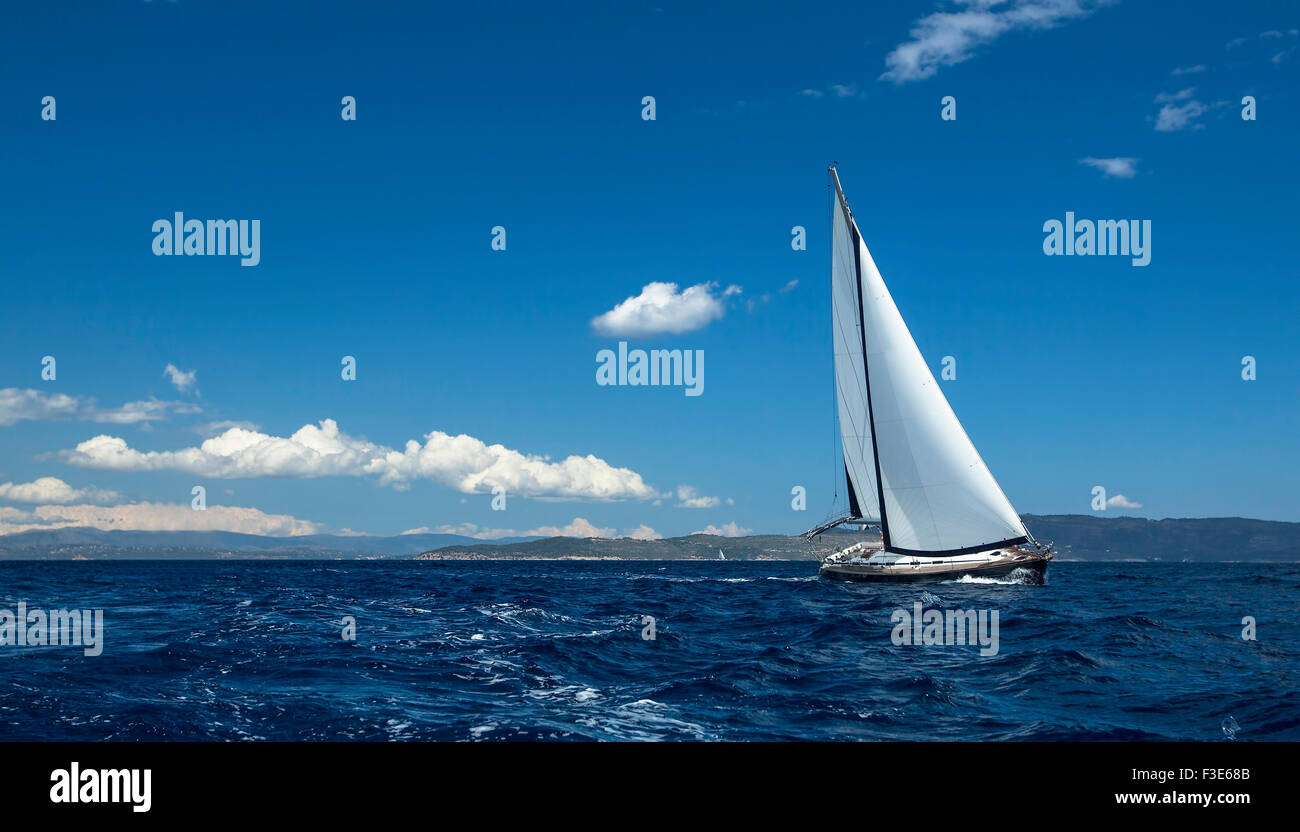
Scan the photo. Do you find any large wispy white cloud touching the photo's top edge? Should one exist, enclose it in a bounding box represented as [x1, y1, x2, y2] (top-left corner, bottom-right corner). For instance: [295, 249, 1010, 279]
[880, 0, 1104, 83]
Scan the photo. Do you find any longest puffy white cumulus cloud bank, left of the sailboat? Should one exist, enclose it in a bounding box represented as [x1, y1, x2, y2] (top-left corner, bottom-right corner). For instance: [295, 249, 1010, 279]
[61, 419, 658, 501]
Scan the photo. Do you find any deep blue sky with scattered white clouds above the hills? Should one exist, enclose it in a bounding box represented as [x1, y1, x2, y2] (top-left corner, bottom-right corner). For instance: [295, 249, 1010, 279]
[0, 0, 1300, 536]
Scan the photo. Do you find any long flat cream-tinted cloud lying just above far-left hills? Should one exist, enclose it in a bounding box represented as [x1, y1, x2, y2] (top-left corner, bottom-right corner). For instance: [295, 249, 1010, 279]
[0, 503, 319, 537]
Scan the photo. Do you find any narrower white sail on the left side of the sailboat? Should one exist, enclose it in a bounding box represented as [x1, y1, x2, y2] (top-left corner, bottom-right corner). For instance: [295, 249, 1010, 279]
[831, 174, 880, 520]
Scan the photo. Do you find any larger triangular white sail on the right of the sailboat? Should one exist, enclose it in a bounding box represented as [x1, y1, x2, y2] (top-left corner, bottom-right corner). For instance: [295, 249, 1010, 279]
[836, 170, 1027, 555]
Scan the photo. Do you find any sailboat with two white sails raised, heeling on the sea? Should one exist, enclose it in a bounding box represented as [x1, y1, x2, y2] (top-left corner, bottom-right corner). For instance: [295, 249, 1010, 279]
[805, 165, 1052, 584]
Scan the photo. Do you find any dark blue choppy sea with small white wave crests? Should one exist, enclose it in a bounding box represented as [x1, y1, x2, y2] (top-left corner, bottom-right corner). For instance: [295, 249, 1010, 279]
[0, 560, 1300, 742]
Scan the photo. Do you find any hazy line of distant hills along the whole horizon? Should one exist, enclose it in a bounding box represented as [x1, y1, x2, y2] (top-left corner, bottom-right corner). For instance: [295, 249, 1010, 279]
[0, 515, 1300, 563]
